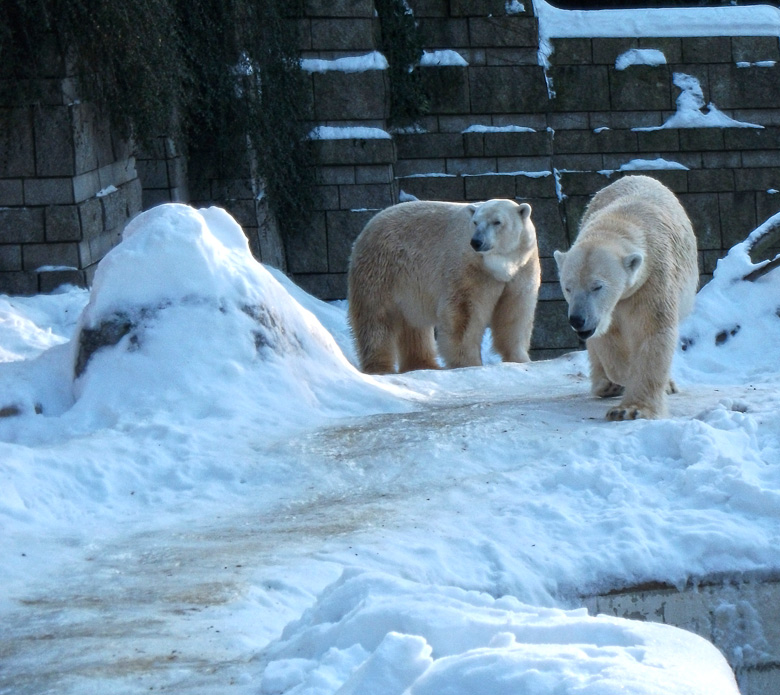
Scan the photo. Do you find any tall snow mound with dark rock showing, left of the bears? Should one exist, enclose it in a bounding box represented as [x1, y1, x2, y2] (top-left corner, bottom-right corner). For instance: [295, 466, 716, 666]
[3, 204, 408, 436]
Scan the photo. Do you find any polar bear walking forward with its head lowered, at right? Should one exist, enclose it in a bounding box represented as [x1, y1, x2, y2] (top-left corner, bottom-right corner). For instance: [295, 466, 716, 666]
[554, 176, 699, 420]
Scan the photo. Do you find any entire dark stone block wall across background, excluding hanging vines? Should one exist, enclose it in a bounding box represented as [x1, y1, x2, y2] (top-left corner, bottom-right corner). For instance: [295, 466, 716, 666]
[0, 0, 780, 358]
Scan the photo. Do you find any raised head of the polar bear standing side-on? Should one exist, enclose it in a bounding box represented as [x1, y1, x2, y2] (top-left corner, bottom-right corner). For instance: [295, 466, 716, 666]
[468, 198, 536, 282]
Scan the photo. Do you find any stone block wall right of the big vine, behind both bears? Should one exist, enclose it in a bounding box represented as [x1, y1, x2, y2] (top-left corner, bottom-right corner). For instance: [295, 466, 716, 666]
[289, 0, 780, 358]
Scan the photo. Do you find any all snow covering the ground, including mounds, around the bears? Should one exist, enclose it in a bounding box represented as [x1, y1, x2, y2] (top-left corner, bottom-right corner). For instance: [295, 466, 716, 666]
[0, 204, 780, 695]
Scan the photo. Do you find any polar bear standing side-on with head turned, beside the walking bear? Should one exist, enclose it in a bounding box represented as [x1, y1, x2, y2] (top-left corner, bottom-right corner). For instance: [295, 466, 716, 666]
[348, 199, 541, 374]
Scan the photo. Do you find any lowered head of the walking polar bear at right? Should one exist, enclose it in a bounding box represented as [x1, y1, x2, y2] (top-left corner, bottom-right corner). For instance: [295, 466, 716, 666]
[554, 238, 645, 340]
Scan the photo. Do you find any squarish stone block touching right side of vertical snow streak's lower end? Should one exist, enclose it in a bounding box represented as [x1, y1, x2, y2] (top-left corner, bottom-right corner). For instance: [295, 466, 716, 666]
[548, 65, 612, 111]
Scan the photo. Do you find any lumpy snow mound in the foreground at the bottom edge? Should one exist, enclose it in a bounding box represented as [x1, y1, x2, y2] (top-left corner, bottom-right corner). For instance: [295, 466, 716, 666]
[260, 570, 738, 695]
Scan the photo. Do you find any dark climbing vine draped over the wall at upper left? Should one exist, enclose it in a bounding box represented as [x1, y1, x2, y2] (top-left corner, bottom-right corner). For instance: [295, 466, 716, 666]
[0, 0, 312, 242]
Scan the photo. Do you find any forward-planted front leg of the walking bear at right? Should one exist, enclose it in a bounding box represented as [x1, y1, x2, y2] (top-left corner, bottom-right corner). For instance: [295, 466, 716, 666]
[607, 328, 676, 421]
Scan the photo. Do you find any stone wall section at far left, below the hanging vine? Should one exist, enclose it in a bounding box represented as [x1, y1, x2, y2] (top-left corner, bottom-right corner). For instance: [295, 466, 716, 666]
[0, 52, 142, 294]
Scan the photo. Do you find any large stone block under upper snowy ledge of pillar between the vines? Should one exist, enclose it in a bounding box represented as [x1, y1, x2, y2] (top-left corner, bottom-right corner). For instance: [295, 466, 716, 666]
[312, 70, 389, 121]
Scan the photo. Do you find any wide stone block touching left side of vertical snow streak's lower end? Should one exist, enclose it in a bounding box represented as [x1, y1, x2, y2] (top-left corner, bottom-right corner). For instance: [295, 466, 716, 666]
[469, 66, 548, 114]
